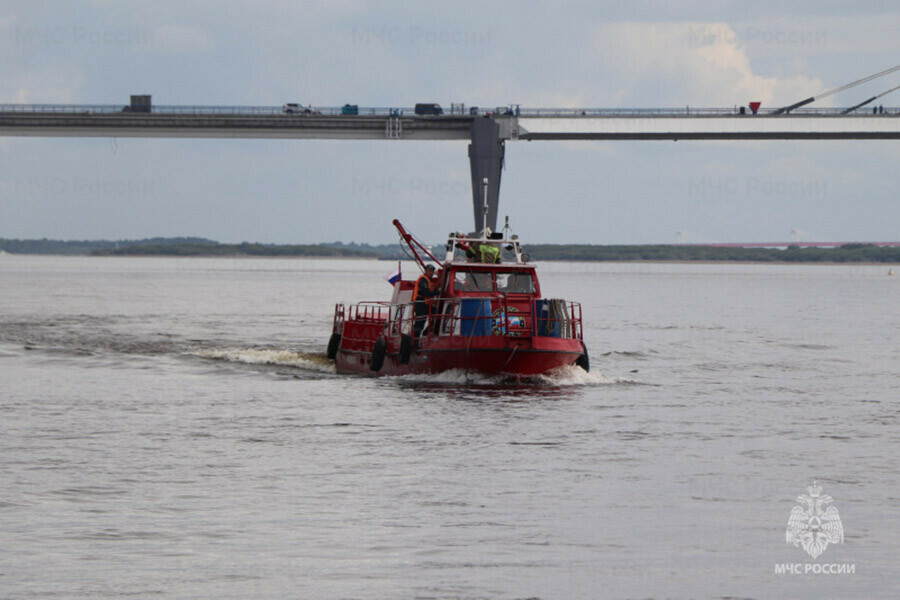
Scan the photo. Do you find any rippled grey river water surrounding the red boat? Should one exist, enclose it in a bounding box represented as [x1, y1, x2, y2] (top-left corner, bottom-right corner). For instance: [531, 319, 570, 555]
[0, 255, 900, 599]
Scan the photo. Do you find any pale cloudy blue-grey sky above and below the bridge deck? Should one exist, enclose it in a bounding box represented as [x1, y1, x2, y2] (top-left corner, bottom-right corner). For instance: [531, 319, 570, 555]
[0, 0, 900, 244]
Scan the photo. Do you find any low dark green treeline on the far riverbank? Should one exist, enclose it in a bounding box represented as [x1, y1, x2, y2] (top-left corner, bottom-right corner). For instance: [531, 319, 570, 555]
[0, 237, 900, 263]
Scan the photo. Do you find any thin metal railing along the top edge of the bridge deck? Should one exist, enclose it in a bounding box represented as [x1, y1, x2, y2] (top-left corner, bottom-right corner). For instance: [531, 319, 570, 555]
[0, 104, 900, 118]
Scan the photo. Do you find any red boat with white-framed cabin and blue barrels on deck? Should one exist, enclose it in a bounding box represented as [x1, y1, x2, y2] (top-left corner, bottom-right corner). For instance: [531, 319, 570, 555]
[327, 220, 590, 376]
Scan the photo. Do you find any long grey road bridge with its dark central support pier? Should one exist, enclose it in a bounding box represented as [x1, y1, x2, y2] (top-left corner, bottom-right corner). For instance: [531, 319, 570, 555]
[0, 97, 900, 228]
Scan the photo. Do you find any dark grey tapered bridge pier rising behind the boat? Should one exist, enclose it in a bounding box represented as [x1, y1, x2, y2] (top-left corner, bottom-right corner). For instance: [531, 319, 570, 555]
[469, 118, 504, 231]
